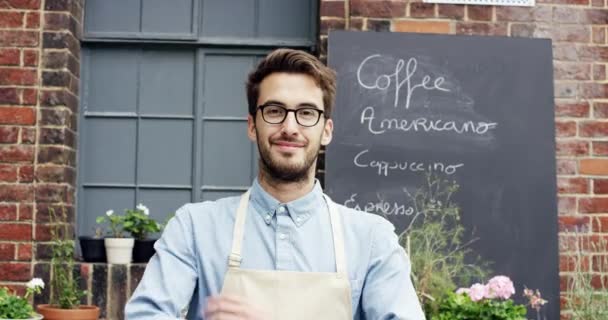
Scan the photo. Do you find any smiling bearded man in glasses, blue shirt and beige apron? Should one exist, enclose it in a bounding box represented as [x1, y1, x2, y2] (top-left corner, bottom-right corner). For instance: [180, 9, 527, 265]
[126, 49, 424, 320]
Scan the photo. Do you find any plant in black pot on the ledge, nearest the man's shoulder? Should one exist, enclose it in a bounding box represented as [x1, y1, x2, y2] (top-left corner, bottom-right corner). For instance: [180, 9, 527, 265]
[123, 203, 163, 262]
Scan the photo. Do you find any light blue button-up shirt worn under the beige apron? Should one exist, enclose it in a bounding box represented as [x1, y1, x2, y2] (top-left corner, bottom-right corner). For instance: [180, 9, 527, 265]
[125, 180, 424, 320]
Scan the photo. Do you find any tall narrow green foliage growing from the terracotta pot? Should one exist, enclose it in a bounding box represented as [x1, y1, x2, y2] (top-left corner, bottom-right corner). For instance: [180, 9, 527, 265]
[49, 208, 86, 309]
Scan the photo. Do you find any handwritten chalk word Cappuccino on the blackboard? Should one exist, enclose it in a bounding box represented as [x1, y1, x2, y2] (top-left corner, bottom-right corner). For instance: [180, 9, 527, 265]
[353, 149, 464, 177]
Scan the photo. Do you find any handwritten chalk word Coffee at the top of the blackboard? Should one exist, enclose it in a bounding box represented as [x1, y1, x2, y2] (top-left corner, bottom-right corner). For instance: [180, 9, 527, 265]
[357, 54, 450, 109]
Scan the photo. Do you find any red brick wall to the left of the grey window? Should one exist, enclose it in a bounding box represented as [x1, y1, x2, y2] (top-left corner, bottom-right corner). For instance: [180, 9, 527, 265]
[0, 0, 83, 291]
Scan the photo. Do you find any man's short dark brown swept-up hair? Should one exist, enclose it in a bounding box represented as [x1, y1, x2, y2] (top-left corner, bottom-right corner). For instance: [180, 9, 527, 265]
[246, 49, 336, 118]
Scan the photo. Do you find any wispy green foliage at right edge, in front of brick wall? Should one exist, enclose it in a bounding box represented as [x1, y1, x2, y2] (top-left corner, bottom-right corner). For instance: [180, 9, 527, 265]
[564, 228, 608, 320]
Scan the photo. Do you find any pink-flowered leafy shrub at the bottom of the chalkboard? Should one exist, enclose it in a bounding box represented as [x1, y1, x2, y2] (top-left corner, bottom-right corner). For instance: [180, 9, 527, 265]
[431, 276, 547, 320]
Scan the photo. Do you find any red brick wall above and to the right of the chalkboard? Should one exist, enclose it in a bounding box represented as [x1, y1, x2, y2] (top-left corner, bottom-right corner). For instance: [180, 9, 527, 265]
[320, 0, 608, 316]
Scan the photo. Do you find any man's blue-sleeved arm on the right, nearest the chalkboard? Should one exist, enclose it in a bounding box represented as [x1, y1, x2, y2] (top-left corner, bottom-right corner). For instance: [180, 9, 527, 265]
[361, 219, 425, 320]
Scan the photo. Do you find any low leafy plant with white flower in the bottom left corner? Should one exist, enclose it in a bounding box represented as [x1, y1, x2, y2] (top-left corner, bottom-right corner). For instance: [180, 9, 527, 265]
[0, 278, 44, 320]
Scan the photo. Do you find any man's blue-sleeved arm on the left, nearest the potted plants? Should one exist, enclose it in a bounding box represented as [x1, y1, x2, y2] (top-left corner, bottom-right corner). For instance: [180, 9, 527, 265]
[125, 206, 198, 320]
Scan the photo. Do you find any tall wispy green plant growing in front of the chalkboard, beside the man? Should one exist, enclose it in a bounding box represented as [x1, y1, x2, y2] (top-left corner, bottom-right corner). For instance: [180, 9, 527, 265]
[399, 174, 490, 318]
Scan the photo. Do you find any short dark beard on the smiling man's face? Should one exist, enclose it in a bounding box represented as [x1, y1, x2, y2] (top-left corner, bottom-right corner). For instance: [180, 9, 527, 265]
[256, 131, 321, 182]
